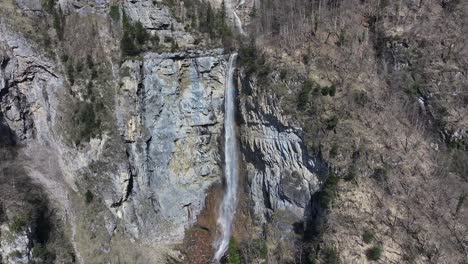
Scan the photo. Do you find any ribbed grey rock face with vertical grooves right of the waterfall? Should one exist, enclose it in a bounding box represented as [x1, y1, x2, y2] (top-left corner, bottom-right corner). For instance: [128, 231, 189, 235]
[239, 78, 326, 221]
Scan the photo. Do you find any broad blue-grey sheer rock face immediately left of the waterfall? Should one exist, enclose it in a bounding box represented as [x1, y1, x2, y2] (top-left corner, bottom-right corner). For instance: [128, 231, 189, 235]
[114, 50, 225, 242]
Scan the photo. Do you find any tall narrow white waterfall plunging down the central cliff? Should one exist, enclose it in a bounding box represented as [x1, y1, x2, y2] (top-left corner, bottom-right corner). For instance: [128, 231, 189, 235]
[214, 53, 238, 263]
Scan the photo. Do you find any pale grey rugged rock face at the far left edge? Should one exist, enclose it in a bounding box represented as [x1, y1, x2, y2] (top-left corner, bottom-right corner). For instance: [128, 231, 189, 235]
[0, 23, 63, 144]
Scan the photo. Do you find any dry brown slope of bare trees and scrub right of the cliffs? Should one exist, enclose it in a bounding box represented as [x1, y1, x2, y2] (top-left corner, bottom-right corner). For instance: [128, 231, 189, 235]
[241, 0, 468, 263]
